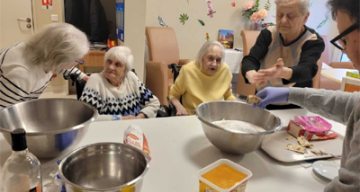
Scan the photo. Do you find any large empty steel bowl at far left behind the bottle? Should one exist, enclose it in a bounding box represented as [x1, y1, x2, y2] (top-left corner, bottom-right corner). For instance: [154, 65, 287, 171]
[0, 99, 98, 159]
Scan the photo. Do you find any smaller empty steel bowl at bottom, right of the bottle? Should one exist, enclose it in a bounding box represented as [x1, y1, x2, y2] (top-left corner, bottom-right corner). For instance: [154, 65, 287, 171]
[59, 143, 149, 192]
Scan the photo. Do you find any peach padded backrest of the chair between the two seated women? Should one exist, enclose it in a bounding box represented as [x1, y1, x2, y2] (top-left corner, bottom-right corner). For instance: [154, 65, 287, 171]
[145, 27, 180, 65]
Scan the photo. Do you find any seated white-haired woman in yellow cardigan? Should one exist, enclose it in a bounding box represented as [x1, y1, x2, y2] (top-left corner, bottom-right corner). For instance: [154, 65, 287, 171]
[169, 41, 235, 115]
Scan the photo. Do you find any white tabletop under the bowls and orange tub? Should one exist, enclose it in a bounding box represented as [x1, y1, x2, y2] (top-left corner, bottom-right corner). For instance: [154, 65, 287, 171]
[0, 109, 345, 192]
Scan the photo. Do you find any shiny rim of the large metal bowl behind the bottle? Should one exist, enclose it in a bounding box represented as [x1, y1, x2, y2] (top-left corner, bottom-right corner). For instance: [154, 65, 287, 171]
[0, 98, 99, 136]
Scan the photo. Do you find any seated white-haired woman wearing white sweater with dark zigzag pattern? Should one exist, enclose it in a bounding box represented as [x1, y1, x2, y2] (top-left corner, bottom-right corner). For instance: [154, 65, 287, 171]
[80, 46, 160, 120]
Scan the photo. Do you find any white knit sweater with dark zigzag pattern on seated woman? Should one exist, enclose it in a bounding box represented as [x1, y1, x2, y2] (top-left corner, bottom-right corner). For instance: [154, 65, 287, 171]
[80, 71, 160, 118]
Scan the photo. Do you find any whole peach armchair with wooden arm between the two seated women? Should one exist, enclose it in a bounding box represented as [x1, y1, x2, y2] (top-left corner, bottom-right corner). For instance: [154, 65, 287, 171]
[145, 27, 189, 105]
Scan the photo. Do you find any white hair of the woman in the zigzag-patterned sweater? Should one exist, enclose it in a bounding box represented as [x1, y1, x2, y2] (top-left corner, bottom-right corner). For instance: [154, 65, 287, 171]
[104, 46, 134, 73]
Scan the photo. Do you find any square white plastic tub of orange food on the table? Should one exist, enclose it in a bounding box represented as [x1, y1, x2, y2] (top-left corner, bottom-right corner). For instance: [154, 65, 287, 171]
[199, 159, 252, 192]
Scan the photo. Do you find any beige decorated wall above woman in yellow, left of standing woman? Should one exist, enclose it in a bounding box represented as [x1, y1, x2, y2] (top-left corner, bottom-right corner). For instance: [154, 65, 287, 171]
[146, 0, 244, 58]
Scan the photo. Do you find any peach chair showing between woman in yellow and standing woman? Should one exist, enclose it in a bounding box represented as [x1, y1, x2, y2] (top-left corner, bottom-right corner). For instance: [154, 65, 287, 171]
[236, 30, 260, 96]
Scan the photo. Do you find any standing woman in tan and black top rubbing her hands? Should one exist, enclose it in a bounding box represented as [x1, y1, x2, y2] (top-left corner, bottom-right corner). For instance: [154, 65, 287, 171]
[241, 0, 325, 109]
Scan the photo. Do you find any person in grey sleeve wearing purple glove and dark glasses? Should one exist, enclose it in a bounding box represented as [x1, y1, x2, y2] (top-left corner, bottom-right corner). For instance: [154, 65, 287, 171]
[257, 0, 360, 192]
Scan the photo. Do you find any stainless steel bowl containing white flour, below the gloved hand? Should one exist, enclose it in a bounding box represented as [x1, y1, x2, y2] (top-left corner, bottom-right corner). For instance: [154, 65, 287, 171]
[196, 101, 281, 154]
